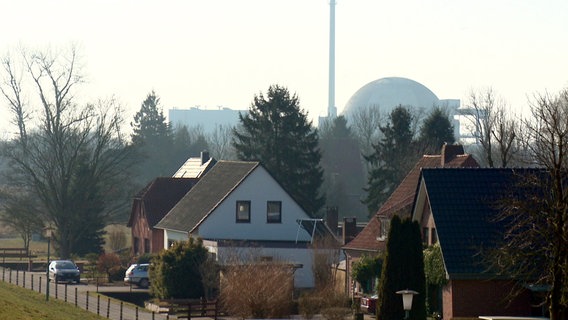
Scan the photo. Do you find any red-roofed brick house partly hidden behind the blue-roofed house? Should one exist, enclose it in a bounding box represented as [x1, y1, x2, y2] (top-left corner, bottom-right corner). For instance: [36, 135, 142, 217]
[343, 144, 479, 295]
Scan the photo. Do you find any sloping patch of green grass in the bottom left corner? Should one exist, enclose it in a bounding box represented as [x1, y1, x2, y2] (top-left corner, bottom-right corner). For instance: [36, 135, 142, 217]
[0, 281, 104, 320]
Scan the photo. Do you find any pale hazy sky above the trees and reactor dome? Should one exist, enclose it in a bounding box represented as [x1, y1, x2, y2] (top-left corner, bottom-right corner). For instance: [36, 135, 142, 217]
[0, 0, 568, 135]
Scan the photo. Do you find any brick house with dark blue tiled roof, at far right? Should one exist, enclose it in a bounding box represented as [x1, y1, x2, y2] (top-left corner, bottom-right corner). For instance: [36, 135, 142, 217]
[412, 168, 544, 319]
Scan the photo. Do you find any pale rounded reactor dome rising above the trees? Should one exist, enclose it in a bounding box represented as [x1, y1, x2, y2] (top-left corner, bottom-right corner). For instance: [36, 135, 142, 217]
[343, 77, 440, 117]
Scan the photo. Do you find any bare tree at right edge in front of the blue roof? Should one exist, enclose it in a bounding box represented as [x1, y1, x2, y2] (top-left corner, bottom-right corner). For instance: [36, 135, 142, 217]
[491, 89, 568, 320]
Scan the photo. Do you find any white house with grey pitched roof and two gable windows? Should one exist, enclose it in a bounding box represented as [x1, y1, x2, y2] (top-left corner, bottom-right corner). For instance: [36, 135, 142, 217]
[156, 161, 332, 288]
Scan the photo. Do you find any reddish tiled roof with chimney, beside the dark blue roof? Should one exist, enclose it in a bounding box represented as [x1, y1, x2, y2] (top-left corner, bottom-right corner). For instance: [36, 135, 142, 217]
[343, 145, 479, 252]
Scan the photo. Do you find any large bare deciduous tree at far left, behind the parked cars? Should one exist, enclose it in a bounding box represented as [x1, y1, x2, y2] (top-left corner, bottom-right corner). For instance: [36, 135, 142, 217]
[2, 46, 132, 258]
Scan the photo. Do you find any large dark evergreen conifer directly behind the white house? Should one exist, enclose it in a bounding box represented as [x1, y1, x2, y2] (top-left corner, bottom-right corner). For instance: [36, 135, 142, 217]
[232, 85, 324, 216]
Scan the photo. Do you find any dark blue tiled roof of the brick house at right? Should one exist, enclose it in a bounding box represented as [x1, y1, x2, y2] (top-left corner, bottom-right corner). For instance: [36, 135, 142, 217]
[422, 168, 542, 278]
